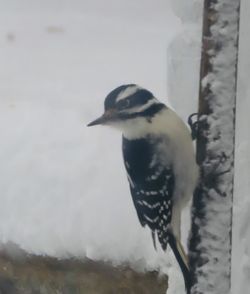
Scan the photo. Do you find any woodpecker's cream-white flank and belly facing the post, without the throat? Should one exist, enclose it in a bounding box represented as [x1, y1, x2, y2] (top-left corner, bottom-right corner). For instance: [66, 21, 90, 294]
[154, 109, 199, 240]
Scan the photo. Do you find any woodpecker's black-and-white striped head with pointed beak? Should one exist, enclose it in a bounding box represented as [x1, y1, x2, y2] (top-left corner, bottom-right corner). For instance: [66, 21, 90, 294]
[88, 84, 165, 137]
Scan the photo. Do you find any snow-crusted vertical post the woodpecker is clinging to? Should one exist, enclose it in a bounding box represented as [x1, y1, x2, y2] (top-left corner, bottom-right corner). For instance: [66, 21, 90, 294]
[189, 0, 240, 294]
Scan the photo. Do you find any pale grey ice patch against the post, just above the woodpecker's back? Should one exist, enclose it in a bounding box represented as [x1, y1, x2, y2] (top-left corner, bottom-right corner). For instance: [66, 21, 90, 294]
[167, 25, 201, 121]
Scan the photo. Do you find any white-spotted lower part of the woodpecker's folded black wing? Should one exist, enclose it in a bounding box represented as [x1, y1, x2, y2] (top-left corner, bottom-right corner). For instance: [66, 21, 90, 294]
[128, 167, 174, 250]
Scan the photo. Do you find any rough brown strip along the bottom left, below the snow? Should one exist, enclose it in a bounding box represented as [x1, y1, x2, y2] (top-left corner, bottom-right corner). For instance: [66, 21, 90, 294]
[0, 245, 167, 294]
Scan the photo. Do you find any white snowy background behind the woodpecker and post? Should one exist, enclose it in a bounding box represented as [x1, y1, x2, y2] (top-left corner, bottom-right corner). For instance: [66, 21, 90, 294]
[0, 0, 250, 293]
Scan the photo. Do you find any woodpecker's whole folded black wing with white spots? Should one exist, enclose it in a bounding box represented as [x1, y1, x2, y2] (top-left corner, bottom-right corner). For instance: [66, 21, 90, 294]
[123, 139, 174, 250]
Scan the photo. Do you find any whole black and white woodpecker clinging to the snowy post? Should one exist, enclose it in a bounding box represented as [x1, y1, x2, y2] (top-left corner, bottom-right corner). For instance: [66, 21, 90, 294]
[88, 84, 198, 287]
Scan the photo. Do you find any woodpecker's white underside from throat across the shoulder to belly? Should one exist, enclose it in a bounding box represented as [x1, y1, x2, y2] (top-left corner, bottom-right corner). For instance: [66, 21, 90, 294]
[123, 108, 198, 206]
